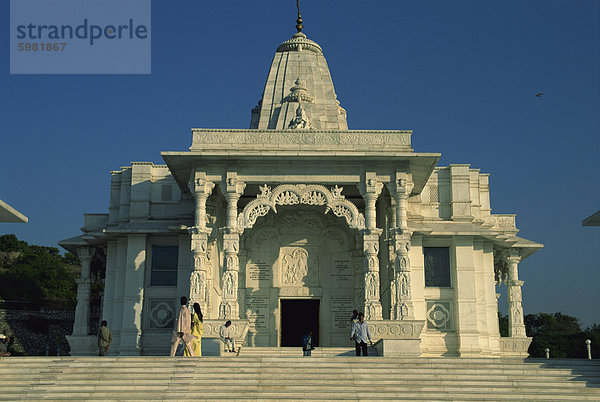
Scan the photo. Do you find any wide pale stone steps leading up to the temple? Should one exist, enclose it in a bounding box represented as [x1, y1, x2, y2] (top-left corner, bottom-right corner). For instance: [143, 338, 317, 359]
[0, 351, 600, 401]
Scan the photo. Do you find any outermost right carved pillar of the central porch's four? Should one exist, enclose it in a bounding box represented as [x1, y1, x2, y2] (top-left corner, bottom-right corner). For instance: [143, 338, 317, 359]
[388, 172, 414, 320]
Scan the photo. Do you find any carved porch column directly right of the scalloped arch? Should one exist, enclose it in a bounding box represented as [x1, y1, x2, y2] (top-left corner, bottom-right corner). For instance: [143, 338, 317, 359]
[360, 172, 383, 320]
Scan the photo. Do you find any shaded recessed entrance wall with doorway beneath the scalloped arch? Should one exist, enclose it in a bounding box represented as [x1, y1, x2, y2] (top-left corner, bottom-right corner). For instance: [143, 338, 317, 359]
[240, 205, 364, 346]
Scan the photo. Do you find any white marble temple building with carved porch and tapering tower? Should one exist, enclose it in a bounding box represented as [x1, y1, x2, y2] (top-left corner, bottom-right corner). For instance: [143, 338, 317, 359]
[59, 26, 542, 356]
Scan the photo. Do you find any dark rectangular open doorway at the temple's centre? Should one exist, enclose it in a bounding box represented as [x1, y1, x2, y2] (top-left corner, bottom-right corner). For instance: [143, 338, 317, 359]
[281, 299, 319, 347]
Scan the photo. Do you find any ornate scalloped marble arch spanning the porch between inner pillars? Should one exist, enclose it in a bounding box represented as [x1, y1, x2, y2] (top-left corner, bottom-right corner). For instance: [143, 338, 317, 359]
[238, 184, 365, 229]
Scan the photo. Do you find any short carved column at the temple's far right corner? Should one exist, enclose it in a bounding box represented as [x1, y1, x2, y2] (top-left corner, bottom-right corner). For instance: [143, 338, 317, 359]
[506, 250, 527, 338]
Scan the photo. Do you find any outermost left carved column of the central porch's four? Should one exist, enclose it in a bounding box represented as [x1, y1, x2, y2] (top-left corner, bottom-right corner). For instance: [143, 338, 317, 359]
[189, 172, 215, 318]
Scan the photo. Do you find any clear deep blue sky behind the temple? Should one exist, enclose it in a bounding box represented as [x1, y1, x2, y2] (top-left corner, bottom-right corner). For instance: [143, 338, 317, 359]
[0, 0, 600, 324]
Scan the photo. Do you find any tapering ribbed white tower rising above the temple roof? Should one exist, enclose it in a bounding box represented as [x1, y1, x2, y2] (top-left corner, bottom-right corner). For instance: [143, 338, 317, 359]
[250, 32, 348, 130]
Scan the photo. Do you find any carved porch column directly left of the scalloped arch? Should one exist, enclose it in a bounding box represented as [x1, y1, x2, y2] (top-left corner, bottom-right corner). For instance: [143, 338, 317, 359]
[219, 172, 246, 320]
